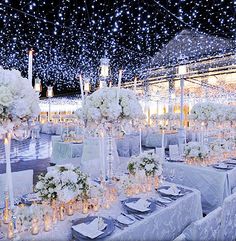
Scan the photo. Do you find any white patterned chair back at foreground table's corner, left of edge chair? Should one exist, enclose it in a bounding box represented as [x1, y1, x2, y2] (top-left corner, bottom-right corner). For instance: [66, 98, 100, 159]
[183, 207, 222, 241]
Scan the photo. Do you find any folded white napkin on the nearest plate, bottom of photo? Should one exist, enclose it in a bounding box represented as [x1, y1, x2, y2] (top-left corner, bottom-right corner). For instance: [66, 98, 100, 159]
[72, 218, 107, 239]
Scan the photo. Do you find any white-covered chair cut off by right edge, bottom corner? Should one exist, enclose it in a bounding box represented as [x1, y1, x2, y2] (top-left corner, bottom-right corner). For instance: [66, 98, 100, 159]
[219, 193, 236, 241]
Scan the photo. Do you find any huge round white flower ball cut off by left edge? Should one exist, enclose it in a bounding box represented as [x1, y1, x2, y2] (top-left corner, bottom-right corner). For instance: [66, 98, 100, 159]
[0, 67, 40, 134]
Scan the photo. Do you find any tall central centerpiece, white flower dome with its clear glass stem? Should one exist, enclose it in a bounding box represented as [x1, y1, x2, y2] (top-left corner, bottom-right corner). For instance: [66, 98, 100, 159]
[77, 87, 143, 184]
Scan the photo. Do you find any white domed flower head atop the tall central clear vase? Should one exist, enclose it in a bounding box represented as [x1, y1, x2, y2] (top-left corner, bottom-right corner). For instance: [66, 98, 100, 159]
[76, 87, 143, 123]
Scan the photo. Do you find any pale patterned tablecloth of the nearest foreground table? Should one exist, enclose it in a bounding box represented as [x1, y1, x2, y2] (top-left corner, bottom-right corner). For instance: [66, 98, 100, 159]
[14, 184, 202, 241]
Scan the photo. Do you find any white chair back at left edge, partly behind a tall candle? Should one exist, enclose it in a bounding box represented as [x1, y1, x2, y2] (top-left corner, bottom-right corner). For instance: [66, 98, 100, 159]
[0, 170, 34, 207]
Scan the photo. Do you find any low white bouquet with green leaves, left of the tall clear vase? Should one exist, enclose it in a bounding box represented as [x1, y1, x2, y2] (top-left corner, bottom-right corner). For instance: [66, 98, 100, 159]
[35, 164, 89, 203]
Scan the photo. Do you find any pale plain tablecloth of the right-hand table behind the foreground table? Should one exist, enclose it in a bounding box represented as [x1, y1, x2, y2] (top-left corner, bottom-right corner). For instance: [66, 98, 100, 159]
[163, 161, 236, 214]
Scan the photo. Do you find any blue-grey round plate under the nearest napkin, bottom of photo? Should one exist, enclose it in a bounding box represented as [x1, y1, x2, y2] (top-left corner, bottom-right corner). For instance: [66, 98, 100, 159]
[71, 216, 115, 241]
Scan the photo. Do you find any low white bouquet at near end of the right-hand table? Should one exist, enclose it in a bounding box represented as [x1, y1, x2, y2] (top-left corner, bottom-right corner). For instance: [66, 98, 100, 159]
[184, 142, 210, 164]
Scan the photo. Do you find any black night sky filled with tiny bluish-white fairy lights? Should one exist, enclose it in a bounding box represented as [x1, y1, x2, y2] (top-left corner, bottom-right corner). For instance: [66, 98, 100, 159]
[0, 0, 236, 96]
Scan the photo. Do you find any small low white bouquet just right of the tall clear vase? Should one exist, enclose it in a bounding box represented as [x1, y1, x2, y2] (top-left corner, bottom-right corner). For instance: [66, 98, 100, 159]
[127, 152, 162, 176]
